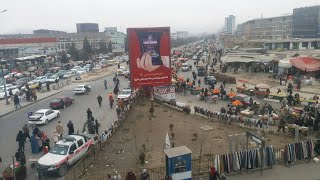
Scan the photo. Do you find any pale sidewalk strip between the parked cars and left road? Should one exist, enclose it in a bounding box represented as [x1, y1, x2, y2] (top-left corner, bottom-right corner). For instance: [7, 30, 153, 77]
[0, 64, 124, 118]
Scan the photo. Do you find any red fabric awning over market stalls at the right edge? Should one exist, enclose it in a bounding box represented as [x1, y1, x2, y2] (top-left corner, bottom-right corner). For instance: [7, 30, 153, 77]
[290, 57, 320, 72]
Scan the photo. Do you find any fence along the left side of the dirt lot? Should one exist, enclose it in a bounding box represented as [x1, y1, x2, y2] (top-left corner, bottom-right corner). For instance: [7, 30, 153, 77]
[65, 92, 141, 180]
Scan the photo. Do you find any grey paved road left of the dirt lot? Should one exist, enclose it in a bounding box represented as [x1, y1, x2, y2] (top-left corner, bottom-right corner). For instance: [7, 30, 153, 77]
[0, 75, 128, 179]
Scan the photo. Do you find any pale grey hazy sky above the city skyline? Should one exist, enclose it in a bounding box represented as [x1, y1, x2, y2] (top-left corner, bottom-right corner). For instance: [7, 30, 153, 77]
[0, 0, 320, 34]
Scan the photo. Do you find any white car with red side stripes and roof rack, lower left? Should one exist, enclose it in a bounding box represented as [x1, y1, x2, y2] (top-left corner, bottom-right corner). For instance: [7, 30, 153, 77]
[37, 134, 95, 176]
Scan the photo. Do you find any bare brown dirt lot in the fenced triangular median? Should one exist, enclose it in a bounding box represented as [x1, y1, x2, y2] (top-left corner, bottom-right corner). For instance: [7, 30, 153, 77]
[82, 101, 293, 175]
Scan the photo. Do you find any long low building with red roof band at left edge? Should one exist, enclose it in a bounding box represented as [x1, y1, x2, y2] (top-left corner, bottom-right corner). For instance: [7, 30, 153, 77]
[0, 37, 57, 58]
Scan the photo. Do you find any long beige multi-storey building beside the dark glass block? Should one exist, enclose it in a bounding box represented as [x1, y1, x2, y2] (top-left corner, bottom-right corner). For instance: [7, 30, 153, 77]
[241, 15, 292, 40]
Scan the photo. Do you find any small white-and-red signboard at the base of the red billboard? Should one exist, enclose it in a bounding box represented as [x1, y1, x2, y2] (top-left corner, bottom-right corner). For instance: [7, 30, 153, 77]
[153, 86, 176, 102]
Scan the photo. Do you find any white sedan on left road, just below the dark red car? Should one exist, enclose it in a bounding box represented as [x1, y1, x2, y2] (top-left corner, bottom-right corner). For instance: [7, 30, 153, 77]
[28, 109, 60, 124]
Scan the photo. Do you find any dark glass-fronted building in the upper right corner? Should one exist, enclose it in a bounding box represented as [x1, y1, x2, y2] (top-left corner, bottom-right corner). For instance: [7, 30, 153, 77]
[292, 6, 320, 38]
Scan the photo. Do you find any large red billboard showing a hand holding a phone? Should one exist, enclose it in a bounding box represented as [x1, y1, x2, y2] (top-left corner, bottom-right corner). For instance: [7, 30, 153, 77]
[127, 27, 171, 89]
